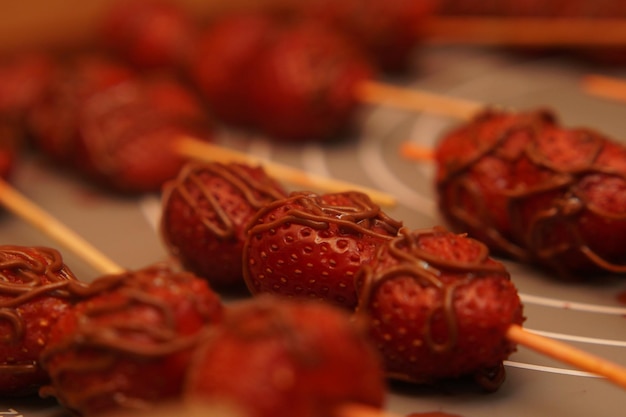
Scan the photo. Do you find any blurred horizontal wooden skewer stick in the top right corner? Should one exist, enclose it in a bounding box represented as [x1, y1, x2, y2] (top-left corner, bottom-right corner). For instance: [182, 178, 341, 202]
[420, 16, 626, 47]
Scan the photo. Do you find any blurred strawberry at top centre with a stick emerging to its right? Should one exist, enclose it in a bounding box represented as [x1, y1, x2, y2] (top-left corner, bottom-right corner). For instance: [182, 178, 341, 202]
[248, 22, 375, 140]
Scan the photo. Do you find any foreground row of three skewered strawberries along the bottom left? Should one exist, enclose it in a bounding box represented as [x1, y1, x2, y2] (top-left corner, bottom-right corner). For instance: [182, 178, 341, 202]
[0, 245, 386, 417]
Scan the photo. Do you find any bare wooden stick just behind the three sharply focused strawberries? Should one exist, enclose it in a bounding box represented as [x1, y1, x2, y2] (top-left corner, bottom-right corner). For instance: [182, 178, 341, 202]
[175, 138, 397, 206]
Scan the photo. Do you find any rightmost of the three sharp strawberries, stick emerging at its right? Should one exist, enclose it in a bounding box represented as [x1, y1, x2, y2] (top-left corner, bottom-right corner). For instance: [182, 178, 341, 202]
[356, 224, 524, 390]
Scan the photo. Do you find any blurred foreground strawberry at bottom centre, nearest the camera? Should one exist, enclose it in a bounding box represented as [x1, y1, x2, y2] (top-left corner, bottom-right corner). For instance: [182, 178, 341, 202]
[185, 295, 385, 417]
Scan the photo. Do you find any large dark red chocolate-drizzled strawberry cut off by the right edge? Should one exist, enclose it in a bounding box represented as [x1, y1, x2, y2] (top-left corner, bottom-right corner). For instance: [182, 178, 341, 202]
[436, 111, 626, 277]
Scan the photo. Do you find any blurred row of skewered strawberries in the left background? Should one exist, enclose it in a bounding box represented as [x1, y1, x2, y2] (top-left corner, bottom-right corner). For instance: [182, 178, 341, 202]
[0, 48, 212, 193]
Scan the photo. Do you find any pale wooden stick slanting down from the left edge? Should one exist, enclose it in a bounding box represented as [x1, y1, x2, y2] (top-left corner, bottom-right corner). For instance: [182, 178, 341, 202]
[0, 179, 123, 274]
